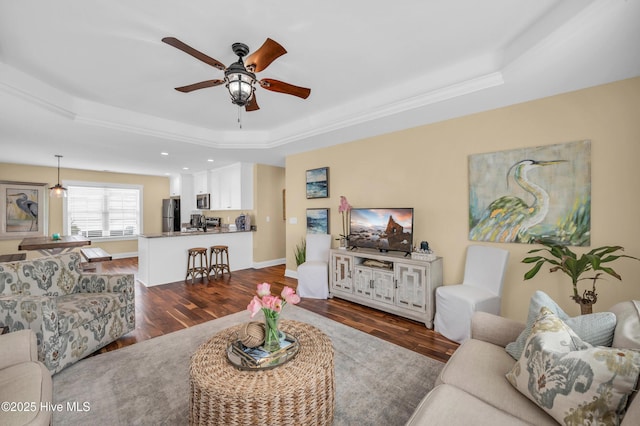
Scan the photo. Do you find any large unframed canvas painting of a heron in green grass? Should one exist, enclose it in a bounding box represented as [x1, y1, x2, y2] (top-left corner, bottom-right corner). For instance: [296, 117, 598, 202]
[469, 141, 591, 246]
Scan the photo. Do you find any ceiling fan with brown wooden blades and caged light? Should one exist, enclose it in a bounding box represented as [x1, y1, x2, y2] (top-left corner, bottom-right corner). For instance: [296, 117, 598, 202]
[162, 37, 311, 111]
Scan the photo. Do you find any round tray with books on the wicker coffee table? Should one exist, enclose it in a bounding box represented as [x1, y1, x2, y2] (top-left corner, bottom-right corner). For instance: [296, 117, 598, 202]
[227, 332, 300, 370]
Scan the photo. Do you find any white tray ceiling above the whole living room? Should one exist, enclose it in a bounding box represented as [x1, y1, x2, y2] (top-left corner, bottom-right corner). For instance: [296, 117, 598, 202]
[0, 0, 640, 175]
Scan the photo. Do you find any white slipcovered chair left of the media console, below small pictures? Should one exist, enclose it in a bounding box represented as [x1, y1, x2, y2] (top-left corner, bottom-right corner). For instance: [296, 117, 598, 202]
[297, 234, 331, 299]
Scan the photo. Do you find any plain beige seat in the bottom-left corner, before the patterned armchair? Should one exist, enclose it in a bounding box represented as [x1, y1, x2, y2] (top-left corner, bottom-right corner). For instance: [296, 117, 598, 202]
[0, 330, 53, 426]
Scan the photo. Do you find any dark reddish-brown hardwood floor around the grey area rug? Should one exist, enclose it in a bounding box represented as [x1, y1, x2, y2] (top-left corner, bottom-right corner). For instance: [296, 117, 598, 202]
[98, 258, 458, 362]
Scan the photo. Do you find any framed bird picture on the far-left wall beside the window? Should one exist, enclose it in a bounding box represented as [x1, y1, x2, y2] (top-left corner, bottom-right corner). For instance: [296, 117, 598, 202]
[0, 181, 49, 240]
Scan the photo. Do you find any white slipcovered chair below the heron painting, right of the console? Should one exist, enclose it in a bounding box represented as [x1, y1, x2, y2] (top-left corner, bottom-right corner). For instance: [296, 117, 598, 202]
[434, 245, 509, 343]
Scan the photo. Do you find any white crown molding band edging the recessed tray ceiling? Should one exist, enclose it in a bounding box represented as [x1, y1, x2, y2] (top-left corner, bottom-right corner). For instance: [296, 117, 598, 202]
[0, 57, 504, 149]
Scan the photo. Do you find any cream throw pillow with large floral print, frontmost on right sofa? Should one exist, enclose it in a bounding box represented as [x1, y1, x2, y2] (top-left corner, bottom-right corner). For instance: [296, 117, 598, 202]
[506, 308, 640, 425]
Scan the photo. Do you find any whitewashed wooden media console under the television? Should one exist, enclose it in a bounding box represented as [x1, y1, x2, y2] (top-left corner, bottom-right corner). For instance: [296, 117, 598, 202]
[329, 248, 442, 328]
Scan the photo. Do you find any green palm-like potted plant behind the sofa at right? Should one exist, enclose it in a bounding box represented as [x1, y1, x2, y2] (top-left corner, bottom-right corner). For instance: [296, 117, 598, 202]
[522, 241, 640, 315]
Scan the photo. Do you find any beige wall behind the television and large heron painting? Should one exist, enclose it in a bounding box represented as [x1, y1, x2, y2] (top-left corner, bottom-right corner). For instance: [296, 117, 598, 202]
[286, 78, 640, 320]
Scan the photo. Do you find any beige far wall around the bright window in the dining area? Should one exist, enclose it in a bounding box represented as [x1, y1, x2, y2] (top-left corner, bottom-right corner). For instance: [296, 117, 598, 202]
[0, 162, 169, 258]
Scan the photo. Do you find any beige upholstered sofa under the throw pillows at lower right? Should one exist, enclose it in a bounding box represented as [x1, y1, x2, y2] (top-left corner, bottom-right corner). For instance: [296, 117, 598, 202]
[407, 302, 640, 426]
